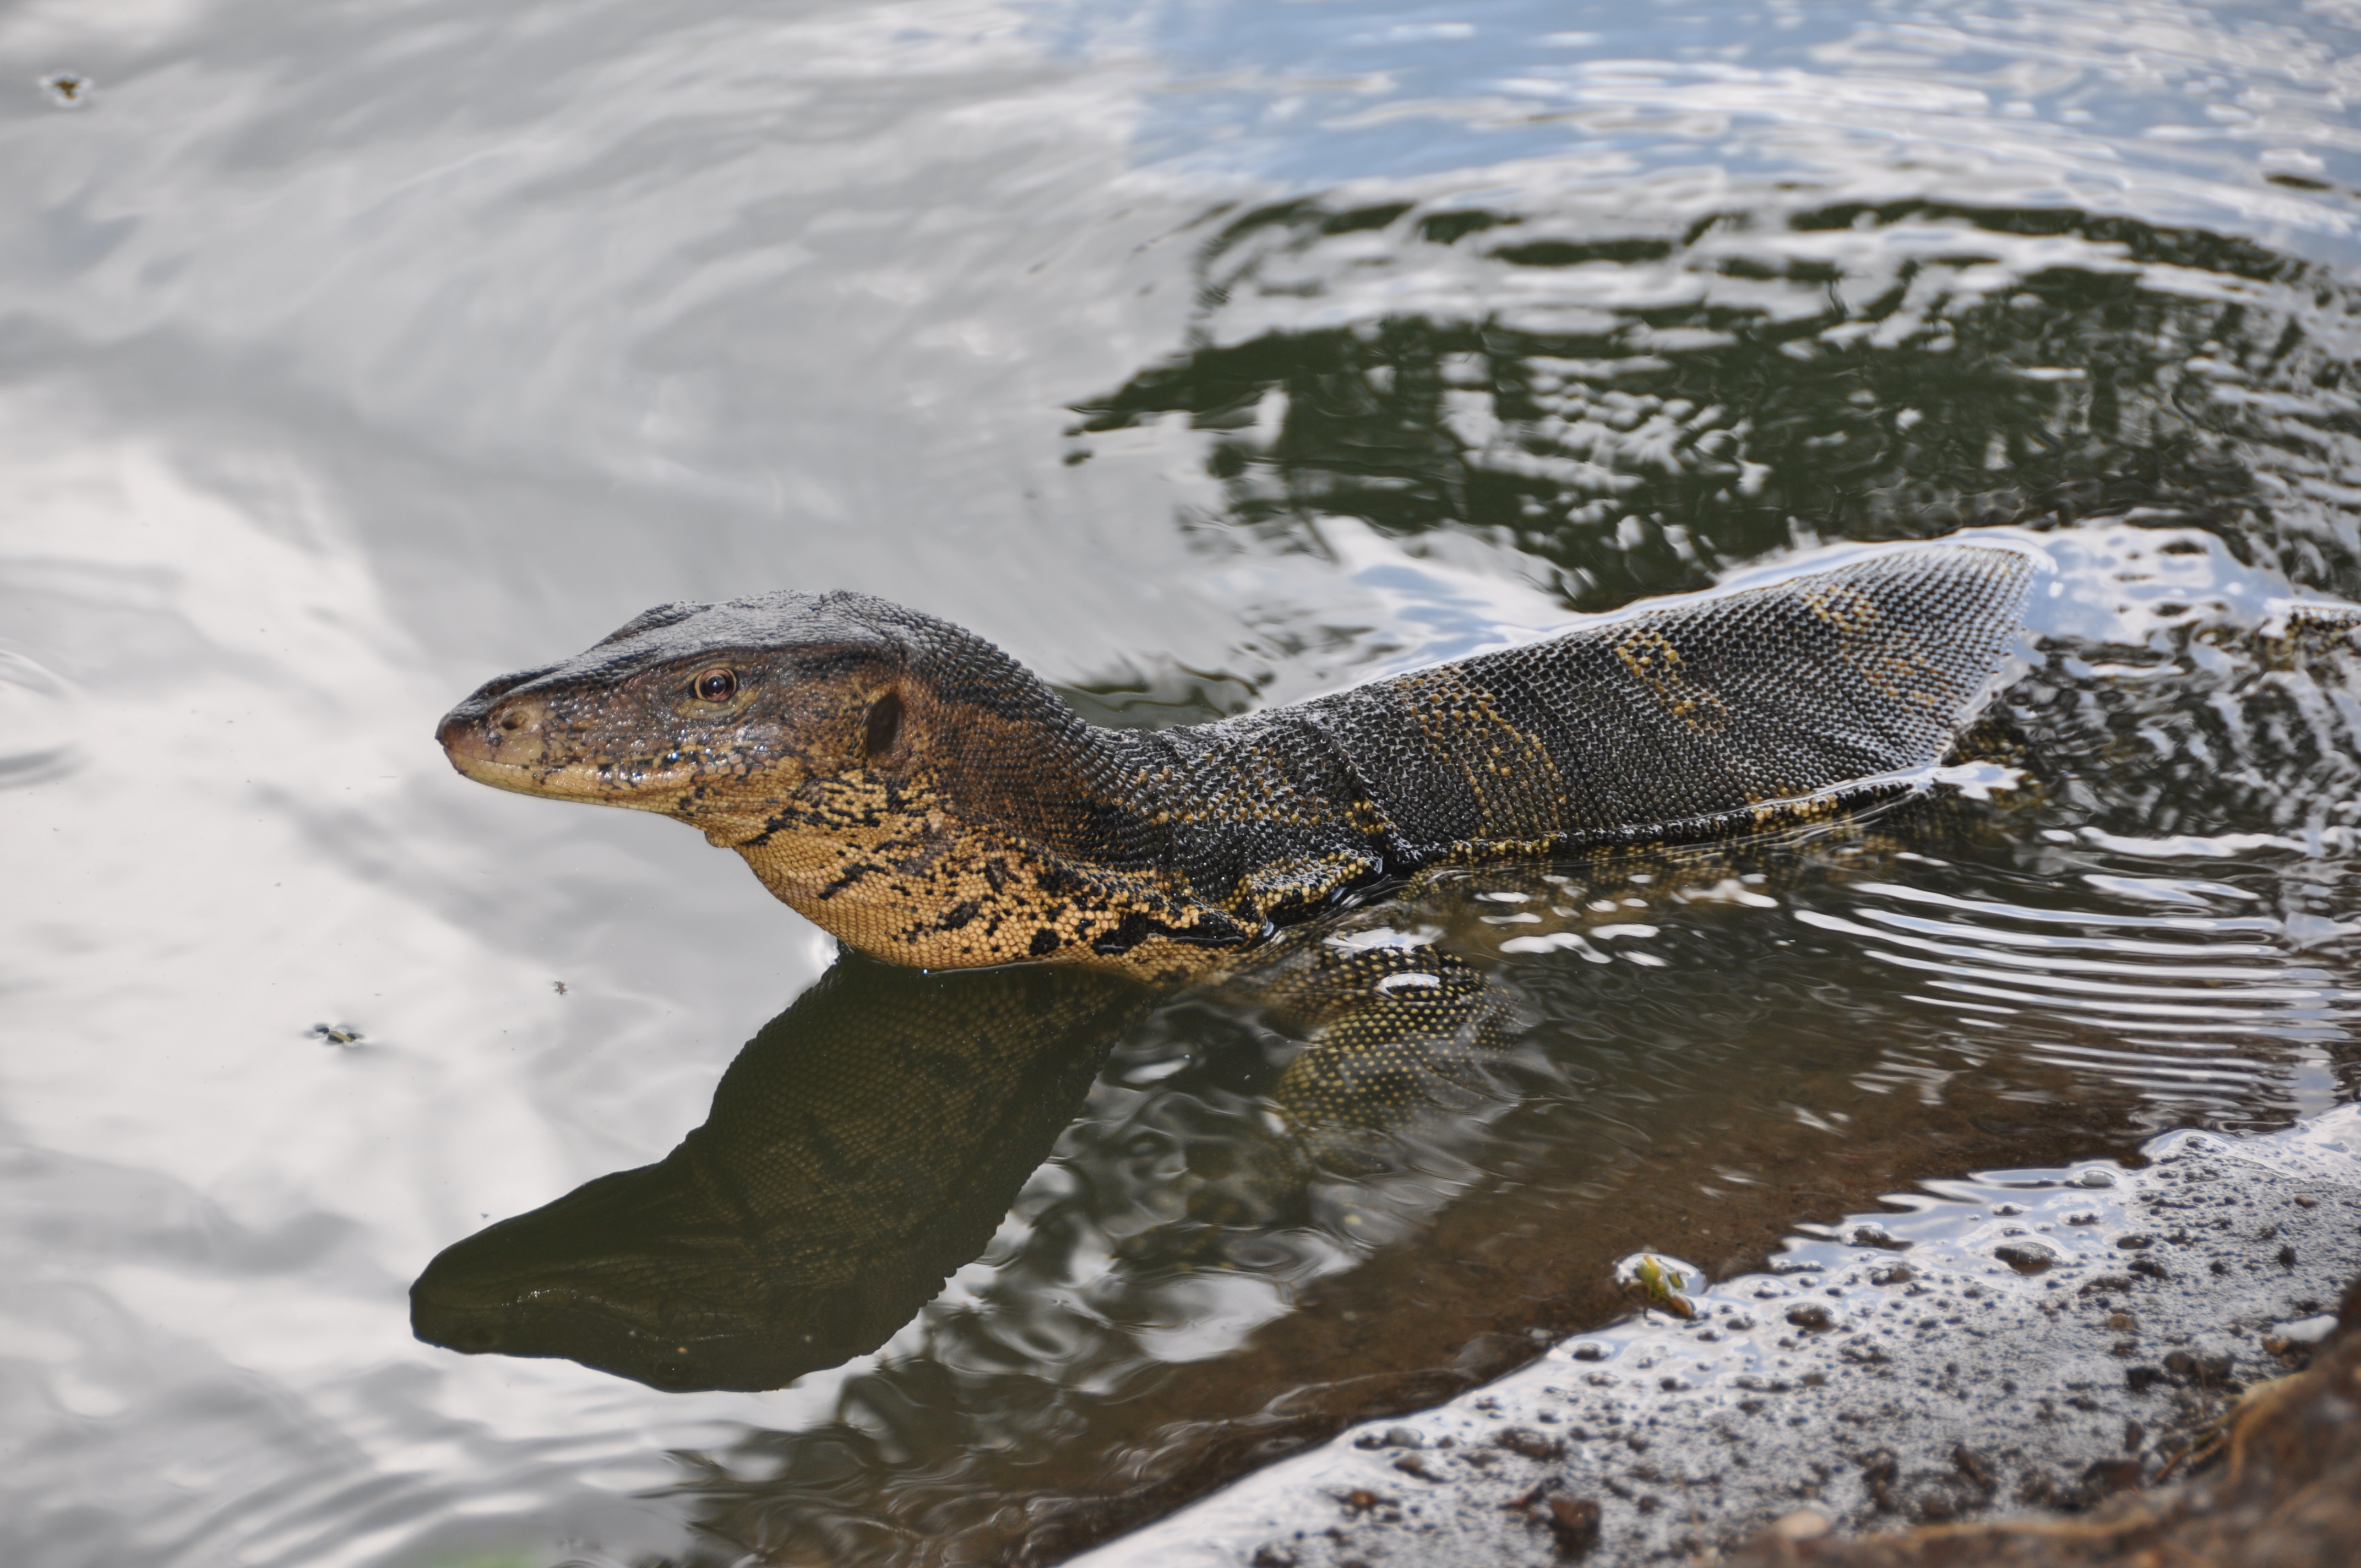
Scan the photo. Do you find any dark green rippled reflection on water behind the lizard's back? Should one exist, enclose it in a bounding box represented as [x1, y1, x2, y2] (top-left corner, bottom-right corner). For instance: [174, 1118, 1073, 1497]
[1076, 201, 2361, 609]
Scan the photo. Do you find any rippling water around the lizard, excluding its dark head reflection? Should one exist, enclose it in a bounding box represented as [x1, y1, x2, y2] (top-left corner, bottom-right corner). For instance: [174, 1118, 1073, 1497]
[0, 0, 2361, 1566]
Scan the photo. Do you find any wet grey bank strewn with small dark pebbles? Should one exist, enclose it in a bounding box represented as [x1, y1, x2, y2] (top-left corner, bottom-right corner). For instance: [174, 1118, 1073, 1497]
[1076, 1108, 2361, 1568]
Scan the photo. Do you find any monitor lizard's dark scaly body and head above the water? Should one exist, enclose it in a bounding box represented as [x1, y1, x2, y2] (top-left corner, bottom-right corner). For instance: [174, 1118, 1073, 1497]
[439, 546, 2031, 980]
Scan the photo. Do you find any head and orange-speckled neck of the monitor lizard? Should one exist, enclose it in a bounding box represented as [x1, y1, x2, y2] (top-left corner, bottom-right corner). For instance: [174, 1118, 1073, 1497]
[437, 593, 1171, 966]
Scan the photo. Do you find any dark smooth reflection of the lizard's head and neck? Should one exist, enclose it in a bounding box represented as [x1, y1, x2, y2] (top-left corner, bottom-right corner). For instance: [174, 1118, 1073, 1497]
[411, 956, 1147, 1389]
